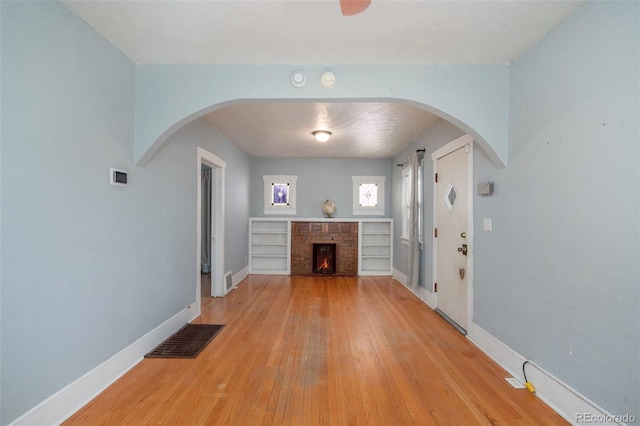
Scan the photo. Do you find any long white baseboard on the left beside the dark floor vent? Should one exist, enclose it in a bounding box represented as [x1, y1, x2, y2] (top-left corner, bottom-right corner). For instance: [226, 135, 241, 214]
[11, 305, 199, 426]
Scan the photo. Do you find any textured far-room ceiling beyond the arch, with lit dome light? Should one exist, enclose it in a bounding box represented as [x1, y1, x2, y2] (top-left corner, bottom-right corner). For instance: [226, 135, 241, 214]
[206, 102, 438, 158]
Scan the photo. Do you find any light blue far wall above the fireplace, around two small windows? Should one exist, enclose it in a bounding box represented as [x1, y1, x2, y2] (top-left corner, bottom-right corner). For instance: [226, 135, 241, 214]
[251, 158, 392, 218]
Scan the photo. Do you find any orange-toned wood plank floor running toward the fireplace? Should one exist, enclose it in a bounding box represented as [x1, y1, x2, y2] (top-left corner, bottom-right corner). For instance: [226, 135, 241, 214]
[66, 275, 566, 426]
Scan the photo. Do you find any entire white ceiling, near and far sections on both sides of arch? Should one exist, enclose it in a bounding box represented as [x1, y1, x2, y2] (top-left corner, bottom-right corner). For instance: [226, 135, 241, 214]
[64, 0, 584, 158]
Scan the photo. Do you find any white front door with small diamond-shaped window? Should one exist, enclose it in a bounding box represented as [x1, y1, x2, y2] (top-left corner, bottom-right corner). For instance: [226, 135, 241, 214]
[434, 136, 471, 333]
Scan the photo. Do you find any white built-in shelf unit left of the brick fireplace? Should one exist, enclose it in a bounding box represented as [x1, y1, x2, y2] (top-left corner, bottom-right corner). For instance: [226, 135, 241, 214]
[249, 218, 291, 275]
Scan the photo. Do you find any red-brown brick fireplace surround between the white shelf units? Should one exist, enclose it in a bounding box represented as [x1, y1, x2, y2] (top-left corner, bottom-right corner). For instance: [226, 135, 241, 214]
[291, 222, 358, 275]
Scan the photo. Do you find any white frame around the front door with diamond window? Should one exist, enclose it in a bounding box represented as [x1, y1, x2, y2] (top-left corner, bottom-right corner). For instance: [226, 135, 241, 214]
[431, 135, 474, 330]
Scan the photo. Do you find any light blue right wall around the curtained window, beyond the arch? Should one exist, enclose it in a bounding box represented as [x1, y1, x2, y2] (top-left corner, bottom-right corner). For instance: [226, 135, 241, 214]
[391, 120, 464, 291]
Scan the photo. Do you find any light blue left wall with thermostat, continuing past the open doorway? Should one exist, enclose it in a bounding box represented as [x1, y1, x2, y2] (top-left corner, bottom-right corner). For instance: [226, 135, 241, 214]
[0, 2, 249, 424]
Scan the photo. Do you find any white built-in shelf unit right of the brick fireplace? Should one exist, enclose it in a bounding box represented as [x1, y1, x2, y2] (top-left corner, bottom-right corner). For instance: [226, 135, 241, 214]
[358, 219, 393, 275]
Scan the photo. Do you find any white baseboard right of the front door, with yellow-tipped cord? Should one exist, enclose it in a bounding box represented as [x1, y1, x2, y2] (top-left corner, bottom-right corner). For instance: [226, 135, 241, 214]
[467, 322, 624, 425]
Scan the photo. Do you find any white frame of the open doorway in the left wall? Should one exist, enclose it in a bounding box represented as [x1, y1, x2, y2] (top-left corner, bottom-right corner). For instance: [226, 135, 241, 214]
[196, 147, 227, 313]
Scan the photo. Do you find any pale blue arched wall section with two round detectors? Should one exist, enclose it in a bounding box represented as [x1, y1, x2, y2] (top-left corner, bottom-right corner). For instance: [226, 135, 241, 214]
[135, 64, 509, 164]
